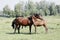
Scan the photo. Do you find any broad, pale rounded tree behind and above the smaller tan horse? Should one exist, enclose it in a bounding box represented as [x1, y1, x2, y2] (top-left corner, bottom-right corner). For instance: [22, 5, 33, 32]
[36, 1, 49, 16]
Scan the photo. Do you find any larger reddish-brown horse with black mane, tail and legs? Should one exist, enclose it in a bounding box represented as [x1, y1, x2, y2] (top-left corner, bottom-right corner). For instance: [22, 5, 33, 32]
[12, 14, 39, 33]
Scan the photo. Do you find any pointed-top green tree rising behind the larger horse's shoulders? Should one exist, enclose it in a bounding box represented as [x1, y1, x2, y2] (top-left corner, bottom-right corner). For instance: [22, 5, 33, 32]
[25, 0, 36, 15]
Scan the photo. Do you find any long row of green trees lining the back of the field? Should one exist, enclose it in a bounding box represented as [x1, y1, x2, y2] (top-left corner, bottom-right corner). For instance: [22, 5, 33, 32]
[0, 1, 60, 17]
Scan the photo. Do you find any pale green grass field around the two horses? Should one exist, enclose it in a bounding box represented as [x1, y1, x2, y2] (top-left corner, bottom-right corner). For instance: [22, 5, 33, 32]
[0, 16, 60, 40]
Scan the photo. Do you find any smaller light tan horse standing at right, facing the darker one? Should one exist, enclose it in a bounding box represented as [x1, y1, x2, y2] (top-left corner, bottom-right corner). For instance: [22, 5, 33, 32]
[32, 16, 48, 33]
